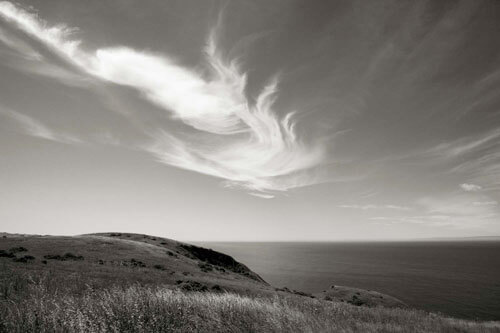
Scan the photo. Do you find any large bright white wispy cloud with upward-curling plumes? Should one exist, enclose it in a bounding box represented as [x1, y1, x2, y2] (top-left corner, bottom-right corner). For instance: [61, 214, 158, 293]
[0, 2, 325, 197]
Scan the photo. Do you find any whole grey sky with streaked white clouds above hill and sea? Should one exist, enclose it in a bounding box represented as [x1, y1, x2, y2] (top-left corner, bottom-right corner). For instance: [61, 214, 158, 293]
[0, 0, 500, 241]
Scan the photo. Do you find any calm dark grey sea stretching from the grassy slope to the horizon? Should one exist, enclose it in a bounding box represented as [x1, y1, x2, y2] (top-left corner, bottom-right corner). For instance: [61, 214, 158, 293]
[198, 241, 500, 320]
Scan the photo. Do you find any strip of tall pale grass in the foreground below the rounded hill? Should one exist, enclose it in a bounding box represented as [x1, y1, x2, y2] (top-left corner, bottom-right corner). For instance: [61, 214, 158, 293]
[0, 271, 500, 332]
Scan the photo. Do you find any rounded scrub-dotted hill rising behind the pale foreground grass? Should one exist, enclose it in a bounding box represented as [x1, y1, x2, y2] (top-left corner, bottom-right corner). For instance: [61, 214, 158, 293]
[0, 233, 274, 293]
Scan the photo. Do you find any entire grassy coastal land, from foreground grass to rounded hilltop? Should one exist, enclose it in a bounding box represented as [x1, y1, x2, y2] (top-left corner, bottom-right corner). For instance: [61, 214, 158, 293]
[0, 233, 500, 332]
